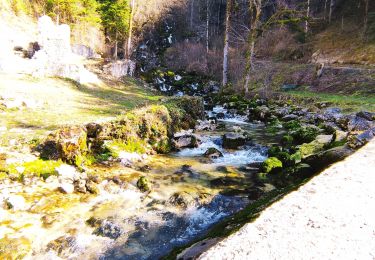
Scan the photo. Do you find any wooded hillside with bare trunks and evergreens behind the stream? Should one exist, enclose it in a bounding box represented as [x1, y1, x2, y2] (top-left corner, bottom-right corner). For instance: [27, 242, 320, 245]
[2, 0, 375, 90]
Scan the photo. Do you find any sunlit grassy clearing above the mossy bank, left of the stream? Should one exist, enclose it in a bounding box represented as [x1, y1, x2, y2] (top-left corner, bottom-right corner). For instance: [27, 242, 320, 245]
[0, 75, 161, 150]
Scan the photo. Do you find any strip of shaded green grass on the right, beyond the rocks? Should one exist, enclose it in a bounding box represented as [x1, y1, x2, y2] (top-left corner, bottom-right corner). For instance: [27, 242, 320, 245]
[285, 90, 375, 112]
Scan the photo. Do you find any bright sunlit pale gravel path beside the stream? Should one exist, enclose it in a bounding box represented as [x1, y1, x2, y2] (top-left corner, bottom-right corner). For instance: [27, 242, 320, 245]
[200, 139, 375, 260]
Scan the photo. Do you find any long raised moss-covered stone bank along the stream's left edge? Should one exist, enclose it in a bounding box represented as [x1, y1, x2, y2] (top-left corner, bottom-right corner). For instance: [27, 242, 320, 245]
[37, 96, 204, 167]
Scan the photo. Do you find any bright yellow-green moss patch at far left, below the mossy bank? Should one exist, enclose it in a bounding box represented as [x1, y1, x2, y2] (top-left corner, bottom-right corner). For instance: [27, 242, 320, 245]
[8, 159, 63, 179]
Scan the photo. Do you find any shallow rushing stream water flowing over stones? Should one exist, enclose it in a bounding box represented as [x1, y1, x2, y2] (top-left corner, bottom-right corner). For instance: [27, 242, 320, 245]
[0, 104, 284, 259]
